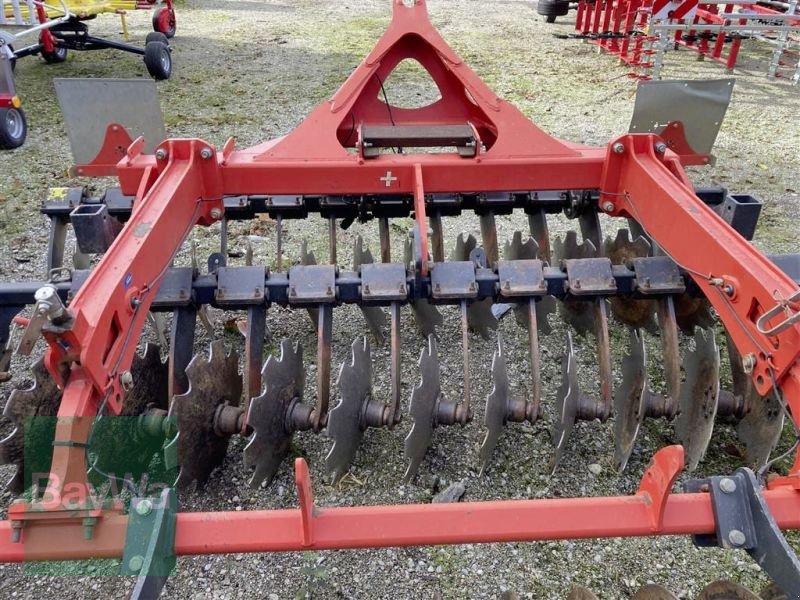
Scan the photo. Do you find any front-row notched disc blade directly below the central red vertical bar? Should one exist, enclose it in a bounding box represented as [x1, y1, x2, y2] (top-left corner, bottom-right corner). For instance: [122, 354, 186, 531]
[403, 335, 441, 482]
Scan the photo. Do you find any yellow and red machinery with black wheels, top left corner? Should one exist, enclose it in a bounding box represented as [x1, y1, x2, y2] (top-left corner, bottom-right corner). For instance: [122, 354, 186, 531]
[0, 0, 176, 150]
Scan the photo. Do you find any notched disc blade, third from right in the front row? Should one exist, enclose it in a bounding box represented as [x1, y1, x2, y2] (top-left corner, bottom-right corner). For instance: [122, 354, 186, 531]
[614, 329, 647, 472]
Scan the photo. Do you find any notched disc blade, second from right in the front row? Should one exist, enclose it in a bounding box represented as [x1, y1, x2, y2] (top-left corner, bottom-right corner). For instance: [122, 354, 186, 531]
[675, 329, 719, 471]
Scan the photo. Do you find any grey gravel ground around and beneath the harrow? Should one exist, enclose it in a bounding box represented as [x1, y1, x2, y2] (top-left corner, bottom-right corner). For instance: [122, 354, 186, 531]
[0, 0, 800, 599]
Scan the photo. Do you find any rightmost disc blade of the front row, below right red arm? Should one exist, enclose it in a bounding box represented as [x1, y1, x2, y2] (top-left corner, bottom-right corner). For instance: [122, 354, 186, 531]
[718, 332, 785, 468]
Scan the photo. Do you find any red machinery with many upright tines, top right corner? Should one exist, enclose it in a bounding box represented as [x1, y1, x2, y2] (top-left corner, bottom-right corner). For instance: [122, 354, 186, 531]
[538, 0, 800, 85]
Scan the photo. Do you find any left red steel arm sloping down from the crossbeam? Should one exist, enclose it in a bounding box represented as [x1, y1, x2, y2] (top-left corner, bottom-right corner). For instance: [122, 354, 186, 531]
[30, 140, 223, 506]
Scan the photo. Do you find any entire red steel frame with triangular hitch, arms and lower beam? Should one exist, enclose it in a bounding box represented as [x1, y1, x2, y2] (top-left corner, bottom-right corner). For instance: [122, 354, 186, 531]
[0, 0, 800, 561]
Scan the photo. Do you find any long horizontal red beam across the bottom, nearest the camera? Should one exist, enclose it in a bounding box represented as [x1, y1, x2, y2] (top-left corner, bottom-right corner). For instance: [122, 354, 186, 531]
[0, 488, 800, 562]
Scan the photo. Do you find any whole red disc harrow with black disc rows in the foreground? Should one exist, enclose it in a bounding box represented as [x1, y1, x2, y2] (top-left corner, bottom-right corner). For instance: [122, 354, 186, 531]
[0, 0, 800, 598]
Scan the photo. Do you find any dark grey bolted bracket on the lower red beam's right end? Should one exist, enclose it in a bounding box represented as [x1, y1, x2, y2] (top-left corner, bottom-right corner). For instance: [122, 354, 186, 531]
[686, 468, 800, 598]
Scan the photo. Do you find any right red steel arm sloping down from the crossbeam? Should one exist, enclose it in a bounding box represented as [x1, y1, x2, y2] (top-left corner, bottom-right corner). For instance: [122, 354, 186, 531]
[600, 135, 800, 474]
